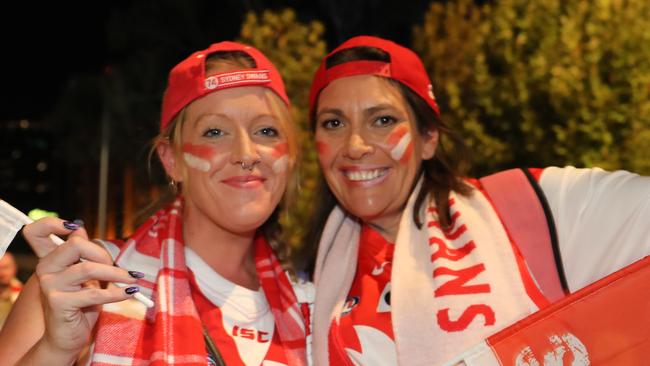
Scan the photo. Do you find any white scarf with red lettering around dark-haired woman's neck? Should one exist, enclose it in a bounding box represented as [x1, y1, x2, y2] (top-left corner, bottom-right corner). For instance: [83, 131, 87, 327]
[313, 179, 546, 366]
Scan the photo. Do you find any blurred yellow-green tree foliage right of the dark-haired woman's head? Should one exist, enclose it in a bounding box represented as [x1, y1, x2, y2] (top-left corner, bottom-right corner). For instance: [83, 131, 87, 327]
[414, 0, 650, 174]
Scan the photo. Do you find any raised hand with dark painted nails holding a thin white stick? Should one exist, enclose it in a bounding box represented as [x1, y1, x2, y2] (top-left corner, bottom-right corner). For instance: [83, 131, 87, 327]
[23, 219, 142, 357]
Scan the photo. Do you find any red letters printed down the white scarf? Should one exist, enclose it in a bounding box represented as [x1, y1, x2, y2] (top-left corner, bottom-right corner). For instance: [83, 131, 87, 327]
[427, 199, 496, 332]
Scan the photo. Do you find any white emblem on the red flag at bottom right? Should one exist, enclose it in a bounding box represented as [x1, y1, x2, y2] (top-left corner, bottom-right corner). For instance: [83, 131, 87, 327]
[515, 333, 590, 366]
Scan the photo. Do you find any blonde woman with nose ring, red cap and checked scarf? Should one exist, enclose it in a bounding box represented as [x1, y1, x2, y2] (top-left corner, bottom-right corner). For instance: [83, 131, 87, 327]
[0, 42, 309, 366]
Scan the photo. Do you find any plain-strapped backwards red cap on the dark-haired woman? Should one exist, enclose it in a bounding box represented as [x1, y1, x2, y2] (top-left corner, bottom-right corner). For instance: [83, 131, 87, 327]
[309, 36, 440, 116]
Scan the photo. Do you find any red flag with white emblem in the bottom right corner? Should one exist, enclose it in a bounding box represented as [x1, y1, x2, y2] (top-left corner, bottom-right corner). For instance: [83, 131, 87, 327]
[487, 257, 650, 365]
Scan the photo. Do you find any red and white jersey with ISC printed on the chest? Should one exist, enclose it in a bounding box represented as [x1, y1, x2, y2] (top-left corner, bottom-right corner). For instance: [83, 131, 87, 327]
[185, 247, 287, 366]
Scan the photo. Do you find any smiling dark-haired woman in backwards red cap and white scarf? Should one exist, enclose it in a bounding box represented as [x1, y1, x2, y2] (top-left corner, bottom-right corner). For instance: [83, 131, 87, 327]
[310, 36, 650, 366]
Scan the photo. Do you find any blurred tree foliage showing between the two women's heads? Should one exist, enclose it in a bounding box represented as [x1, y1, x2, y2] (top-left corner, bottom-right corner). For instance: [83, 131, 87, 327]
[240, 9, 326, 248]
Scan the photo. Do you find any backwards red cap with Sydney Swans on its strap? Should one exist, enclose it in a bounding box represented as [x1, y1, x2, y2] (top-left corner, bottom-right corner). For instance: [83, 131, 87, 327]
[160, 42, 290, 131]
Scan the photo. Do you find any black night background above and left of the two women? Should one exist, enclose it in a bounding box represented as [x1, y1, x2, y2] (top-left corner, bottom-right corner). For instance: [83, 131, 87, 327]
[0, 0, 430, 278]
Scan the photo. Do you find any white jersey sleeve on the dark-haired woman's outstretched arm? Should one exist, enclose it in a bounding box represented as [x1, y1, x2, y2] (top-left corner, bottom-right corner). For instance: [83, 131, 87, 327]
[539, 167, 650, 292]
